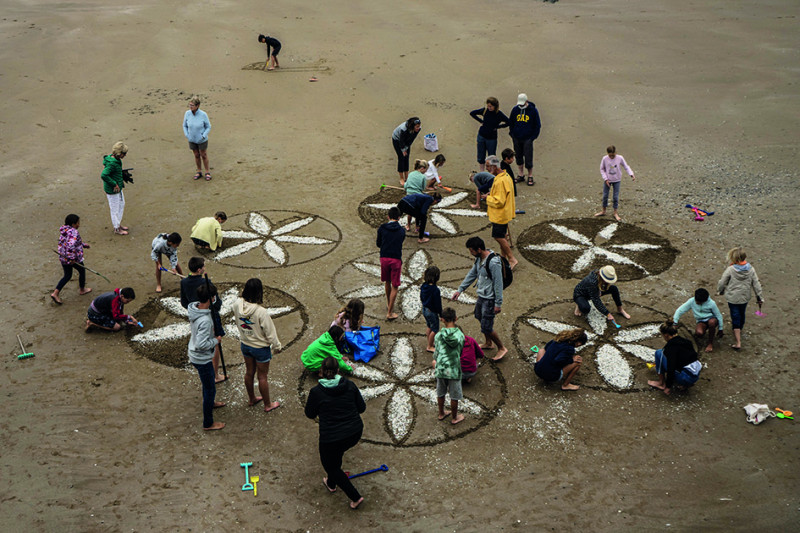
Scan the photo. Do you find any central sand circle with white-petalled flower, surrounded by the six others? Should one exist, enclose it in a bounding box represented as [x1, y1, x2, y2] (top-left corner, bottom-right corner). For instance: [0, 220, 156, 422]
[331, 248, 476, 323]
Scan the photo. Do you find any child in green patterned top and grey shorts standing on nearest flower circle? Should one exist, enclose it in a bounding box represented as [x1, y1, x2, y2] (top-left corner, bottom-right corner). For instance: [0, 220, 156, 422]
[433, 307, 464, 424]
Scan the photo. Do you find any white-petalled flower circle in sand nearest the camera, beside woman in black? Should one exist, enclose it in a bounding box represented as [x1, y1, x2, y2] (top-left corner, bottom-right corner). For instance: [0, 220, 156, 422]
[298, 334, 506, 447]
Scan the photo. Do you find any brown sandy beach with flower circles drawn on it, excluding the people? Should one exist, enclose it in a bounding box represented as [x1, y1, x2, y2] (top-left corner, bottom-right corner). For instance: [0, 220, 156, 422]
[0, 0, 800, 532]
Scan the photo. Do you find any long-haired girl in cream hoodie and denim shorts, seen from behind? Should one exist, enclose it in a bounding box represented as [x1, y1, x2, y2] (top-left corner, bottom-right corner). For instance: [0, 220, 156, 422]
[233, 278, 281, 413]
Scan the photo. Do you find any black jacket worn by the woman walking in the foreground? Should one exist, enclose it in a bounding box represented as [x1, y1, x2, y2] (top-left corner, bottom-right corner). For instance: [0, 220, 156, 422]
[306, 377, 367, 442]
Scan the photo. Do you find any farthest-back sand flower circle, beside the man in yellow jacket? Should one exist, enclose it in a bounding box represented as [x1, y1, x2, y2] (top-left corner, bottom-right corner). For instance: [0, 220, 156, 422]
[358, 188, 489, 239]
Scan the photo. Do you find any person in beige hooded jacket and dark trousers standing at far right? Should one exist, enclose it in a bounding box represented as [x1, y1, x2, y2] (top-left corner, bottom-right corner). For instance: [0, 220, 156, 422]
[717, 246, 764, 350]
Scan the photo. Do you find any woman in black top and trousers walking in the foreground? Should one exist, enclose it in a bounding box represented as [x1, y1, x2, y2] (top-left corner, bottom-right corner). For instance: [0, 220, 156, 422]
[305, 357, 367, 509]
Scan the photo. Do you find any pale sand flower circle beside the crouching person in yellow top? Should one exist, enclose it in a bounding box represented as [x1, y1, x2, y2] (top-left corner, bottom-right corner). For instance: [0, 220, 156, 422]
[210, 210, 342, 268]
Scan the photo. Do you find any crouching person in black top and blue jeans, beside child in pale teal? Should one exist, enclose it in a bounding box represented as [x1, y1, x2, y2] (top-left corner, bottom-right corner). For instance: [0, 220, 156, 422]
[647, 320, 703, 394]
